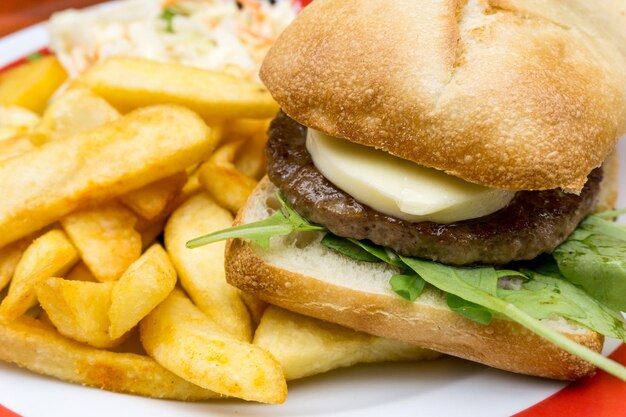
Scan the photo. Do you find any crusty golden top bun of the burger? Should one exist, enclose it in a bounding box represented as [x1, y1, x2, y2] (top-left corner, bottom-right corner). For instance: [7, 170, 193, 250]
[261, 0, 626, 192]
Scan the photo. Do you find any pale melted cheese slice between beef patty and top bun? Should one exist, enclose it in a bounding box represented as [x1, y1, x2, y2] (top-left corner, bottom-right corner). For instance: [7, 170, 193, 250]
[306, 129, 515, 224]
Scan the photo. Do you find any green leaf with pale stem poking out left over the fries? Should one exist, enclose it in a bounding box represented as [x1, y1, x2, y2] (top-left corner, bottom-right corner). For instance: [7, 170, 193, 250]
[187, 196, 326, 249]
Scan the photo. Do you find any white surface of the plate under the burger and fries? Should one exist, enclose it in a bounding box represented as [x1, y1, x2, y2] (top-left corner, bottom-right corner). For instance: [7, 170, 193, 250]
[0, 17, 626, 417]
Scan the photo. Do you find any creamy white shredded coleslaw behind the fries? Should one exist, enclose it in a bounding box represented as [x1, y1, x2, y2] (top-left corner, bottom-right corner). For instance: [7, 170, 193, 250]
[48, 0, 297, 80]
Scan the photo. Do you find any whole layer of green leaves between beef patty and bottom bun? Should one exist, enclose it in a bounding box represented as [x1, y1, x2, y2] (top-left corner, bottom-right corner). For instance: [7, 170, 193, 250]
[187, 195, 626, 381]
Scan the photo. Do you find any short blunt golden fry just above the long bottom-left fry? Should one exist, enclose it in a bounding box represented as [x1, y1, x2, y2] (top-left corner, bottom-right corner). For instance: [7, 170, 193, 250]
[36, 277, 122, 348]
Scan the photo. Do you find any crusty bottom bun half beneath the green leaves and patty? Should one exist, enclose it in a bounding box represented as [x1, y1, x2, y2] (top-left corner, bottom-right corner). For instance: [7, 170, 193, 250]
[226, 179, 604, 380]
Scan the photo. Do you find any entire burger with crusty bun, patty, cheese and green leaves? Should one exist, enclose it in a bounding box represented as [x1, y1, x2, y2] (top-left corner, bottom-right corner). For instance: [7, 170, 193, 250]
[188, 0, 626, 380]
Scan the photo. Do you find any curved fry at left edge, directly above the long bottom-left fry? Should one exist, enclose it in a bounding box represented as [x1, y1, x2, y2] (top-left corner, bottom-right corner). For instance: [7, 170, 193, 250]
[0, 230, 78, 320]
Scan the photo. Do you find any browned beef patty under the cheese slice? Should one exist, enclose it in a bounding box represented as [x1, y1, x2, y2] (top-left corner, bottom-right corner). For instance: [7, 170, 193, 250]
[266, 112, 602, 265]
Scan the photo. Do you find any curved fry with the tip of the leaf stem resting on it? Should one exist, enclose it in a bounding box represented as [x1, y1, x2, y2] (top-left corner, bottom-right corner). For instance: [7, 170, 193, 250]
[165, 194, 252, 341]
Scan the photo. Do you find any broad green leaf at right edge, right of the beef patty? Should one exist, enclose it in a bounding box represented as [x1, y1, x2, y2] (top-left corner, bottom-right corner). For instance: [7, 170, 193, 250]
[553, 212, 626, 311]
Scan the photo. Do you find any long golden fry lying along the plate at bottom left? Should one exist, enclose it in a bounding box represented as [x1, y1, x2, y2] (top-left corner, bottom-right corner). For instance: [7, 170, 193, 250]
[0, 317, 220, 401]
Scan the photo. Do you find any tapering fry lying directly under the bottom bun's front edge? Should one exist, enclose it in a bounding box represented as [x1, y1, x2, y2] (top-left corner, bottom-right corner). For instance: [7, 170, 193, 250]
[254, 306, 440, 380]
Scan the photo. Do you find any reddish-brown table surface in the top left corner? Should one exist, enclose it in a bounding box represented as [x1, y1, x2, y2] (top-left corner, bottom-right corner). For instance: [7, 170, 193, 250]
[0, 0, 103, 37]
